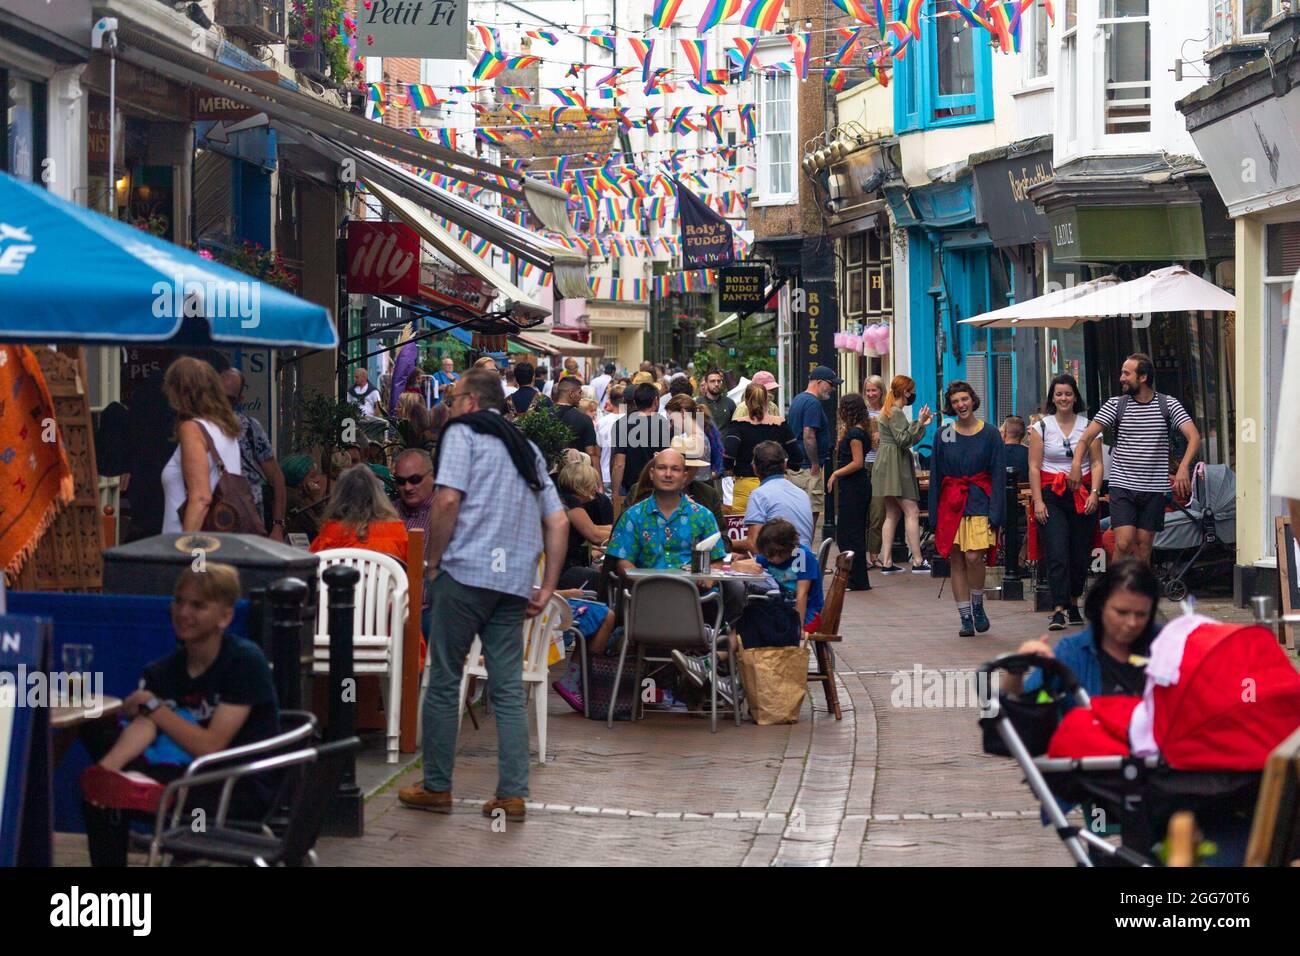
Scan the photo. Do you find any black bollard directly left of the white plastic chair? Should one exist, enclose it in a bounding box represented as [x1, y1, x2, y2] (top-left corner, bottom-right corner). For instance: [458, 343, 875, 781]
[321, 564, 365, 836]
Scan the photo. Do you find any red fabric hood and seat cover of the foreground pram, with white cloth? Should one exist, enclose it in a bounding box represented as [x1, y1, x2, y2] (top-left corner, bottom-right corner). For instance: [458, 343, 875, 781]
[1048, 615, 1300, 770]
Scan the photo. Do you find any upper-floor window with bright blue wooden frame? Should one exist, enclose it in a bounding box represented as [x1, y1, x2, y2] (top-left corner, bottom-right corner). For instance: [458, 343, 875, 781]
[894, 0, 993, 133]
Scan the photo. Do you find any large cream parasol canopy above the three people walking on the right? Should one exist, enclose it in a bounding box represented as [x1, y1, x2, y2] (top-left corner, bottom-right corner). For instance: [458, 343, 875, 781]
[962, 265, 1236, 329]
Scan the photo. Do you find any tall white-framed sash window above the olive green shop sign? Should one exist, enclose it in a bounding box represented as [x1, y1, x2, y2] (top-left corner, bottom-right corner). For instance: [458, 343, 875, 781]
[1097, 0, 1151, 135]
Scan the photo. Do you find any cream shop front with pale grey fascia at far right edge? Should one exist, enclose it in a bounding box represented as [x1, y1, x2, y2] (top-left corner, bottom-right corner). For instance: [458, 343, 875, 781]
[1178, 13, 1300, 604]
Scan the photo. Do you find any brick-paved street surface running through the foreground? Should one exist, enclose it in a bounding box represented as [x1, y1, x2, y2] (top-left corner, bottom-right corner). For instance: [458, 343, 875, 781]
[320, 575, 1218, 866]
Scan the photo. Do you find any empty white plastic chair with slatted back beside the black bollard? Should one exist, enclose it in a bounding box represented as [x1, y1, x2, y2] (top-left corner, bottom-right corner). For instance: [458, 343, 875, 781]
[312, 548, 410, 763]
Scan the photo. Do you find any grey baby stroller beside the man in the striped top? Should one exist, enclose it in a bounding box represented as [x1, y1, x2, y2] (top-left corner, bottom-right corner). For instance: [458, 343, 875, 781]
[1152, 462, 1236, 601]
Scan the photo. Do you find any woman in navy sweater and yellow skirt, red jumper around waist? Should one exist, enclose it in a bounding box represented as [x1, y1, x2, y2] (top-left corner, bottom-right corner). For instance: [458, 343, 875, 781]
[930, 381, 1006, 637]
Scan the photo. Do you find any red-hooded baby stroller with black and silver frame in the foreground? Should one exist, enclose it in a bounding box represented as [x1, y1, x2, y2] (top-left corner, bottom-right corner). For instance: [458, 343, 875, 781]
[980, 615, 1300, 866]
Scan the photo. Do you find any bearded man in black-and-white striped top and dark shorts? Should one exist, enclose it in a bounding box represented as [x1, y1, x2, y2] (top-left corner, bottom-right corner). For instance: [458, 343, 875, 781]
[1070, 352, 1201, 562]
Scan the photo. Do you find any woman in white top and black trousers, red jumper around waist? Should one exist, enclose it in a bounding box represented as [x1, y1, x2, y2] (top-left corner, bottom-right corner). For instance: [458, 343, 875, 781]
[1030, 375, 1102, 631]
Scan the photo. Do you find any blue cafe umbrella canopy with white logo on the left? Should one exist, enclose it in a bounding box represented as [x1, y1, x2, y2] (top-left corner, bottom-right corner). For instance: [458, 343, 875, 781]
[0, 173, 338, 349]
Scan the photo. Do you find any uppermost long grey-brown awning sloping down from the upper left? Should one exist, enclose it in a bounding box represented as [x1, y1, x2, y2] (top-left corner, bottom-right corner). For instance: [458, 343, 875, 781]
[117, 23, 574, 234]
